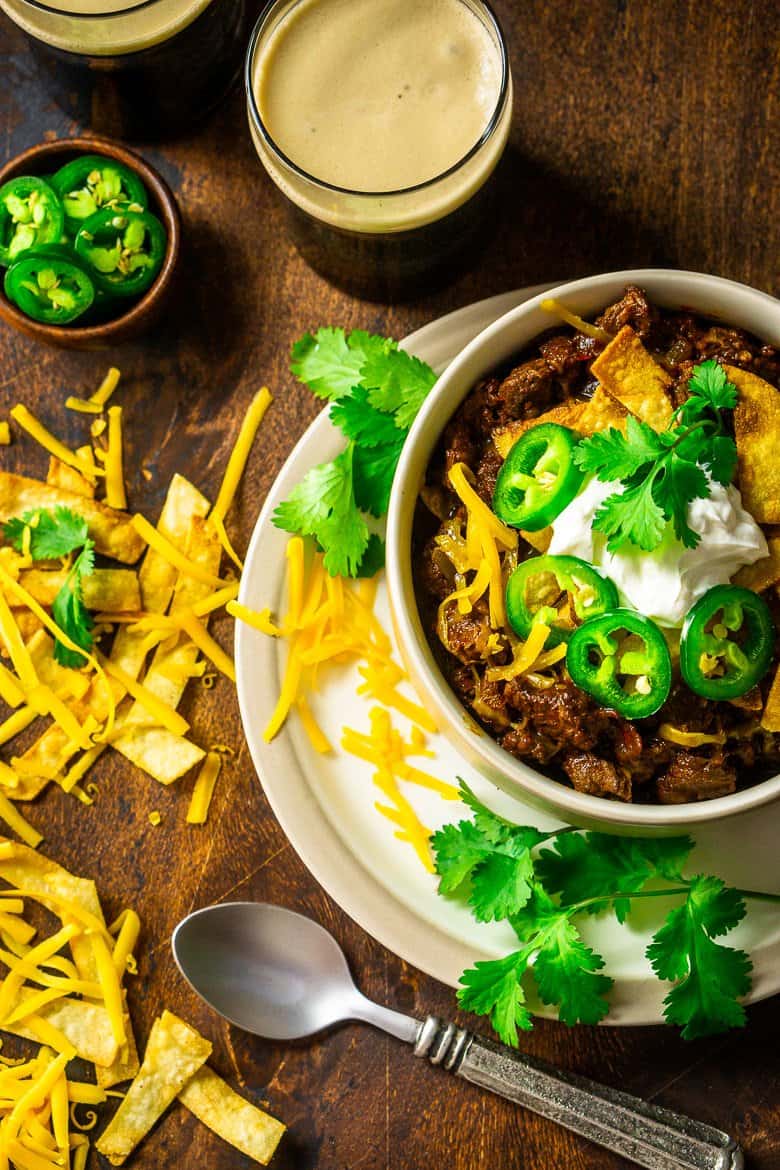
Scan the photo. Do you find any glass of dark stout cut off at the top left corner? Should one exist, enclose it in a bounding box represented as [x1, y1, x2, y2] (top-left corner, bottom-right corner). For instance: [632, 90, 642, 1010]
[0, 0, 244, 138]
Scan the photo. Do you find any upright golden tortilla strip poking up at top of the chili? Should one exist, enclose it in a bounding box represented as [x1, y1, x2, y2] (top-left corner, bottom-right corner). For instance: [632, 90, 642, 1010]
[591, 325, 674, 431]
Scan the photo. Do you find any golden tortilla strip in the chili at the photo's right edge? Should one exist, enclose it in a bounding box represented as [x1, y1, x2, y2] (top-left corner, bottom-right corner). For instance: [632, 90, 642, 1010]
[726, 366, 780, 524]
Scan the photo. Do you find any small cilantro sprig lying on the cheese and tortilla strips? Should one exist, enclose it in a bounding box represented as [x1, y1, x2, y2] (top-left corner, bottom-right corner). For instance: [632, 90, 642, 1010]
[2, 507, 95, 668]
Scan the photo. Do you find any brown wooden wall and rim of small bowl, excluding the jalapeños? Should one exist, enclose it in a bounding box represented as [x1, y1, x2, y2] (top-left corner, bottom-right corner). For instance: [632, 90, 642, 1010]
[0, 138, 181, 350]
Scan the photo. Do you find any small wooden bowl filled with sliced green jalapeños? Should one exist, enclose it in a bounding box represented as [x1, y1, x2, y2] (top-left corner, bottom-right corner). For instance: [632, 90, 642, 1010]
[0, 137, 181, 350]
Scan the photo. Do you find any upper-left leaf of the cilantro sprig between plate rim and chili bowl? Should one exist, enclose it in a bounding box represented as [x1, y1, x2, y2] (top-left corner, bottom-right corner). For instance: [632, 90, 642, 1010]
[290, 328, 395, 399]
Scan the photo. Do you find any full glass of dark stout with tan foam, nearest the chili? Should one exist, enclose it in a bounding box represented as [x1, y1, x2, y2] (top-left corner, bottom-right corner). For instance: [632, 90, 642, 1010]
[246, 0, 512, 301]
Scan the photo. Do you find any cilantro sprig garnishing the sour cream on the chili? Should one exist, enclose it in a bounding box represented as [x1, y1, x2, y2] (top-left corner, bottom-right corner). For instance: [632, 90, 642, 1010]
[574, 360, 738, 552]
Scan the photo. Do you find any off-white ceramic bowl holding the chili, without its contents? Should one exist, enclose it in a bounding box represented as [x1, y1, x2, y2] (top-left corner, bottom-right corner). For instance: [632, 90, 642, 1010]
[387, 268, 780, 833]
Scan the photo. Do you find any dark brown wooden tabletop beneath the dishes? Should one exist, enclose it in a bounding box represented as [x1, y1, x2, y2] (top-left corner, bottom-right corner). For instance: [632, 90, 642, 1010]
[0, 0, 780, 1170]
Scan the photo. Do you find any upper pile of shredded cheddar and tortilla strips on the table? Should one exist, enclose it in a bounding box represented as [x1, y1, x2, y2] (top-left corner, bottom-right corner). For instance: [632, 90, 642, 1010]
[0, 369, 271, 846]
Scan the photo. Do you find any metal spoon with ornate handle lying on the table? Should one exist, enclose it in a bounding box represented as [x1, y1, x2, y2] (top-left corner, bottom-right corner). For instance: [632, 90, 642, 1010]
[172, 902, 744, 1170]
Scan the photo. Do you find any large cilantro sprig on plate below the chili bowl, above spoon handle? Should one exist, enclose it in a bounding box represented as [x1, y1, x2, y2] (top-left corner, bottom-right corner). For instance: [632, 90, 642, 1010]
[432, 782, 780, 1046]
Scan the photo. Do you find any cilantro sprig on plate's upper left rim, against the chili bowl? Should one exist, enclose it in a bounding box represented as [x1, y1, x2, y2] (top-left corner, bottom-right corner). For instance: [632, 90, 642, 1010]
[274, 328, 436, 577]
